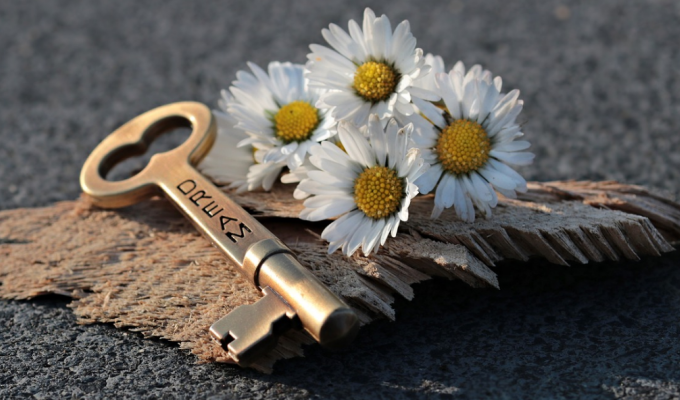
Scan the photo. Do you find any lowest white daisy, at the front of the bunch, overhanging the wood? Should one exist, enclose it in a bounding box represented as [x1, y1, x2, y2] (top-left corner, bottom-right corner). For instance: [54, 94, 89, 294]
[299, 114, 427, 256]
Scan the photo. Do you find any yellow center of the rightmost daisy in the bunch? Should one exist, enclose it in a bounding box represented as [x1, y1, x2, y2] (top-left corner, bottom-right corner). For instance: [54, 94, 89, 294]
[435, 119, 491, 175]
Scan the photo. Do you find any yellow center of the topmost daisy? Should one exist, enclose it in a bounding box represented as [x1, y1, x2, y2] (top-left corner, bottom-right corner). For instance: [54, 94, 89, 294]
[354, 61, 399, 103]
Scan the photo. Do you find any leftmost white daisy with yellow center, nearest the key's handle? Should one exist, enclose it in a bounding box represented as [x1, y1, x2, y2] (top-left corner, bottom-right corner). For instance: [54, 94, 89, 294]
[224, 62, 335, 170]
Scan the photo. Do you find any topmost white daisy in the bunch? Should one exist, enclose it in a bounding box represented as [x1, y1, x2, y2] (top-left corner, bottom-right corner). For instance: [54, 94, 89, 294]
[307, 8, 438, 126]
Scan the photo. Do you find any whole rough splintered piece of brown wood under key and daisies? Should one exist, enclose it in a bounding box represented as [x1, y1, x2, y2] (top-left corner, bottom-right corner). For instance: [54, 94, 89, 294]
[0, 182, 680, 371]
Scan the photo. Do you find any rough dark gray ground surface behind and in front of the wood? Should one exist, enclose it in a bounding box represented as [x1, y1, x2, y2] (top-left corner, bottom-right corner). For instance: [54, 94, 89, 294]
[0, 0, 680, 399]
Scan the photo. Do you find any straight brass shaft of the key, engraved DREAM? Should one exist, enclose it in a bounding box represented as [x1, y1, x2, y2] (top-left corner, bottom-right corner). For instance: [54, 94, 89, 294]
[157, 164, 356, 347]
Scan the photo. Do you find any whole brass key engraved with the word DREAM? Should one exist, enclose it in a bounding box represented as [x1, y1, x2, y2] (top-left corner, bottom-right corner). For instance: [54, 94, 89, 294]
[80, 102, 359, 365]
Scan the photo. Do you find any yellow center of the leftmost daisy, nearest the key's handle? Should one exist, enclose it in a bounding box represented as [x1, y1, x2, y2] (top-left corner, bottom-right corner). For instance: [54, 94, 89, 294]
[274, 100, 319, 144]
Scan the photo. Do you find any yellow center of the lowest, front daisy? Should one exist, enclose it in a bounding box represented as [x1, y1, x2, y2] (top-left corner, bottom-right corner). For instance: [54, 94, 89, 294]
[354, 166, 404, 219]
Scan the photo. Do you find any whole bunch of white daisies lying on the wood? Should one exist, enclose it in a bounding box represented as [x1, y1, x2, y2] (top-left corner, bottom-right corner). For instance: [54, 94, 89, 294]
[201, 8, 534, 256]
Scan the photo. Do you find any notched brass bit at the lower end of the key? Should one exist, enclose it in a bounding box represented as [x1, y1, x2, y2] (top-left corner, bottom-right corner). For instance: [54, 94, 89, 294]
[210, 287, 299, 366]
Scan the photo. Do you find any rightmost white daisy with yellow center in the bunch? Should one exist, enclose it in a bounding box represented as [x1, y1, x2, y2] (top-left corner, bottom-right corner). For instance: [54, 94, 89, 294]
[416, 62, 534, 222]
